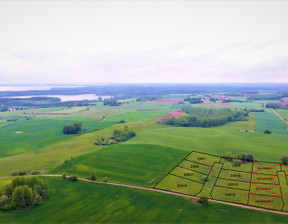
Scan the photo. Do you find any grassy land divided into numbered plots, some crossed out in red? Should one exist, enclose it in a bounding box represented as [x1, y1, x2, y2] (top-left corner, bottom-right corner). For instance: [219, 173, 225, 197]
[154, 151, 288, 212]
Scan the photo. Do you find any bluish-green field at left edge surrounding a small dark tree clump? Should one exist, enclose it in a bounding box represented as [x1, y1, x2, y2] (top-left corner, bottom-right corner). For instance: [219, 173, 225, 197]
[0, 118, 114, 157]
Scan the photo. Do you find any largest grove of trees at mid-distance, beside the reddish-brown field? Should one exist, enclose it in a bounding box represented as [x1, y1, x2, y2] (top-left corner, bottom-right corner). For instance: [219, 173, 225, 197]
[160, 107, 249, 128]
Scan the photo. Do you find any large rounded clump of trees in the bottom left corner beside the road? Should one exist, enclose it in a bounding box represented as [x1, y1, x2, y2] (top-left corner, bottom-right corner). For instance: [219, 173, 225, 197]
[0, 177, 48, 211]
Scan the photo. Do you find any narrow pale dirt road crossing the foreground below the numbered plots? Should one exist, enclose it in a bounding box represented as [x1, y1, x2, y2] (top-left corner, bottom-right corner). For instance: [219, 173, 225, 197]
[0, 174, 288, 215]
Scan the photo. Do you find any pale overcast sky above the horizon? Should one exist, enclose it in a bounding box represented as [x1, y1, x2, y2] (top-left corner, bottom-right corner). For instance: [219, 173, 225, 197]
[0, 0, 288, 84]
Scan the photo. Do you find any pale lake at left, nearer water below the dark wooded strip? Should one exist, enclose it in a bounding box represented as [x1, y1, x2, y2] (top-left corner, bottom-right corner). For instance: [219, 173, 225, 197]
[0, 94, 113, 102]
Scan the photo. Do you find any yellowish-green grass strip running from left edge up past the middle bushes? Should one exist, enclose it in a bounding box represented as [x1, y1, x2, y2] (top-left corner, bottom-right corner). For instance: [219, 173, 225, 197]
[0, 122, 159, 176]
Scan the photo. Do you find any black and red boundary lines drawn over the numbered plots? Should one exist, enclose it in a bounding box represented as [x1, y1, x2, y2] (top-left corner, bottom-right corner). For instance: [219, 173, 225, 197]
[153, 151, 288, 212]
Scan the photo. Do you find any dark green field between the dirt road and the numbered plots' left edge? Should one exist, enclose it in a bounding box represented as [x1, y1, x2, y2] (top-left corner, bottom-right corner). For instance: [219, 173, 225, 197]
[51, 144, 187, 187]
